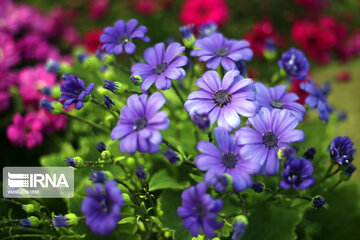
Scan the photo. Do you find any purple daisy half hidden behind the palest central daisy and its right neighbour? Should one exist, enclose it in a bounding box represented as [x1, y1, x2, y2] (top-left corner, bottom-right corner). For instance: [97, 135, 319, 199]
[254, 82, 306, 122]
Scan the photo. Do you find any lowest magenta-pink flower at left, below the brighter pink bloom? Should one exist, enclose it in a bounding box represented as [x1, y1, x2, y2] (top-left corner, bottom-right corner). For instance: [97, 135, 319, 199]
[6, 113, 43, 149]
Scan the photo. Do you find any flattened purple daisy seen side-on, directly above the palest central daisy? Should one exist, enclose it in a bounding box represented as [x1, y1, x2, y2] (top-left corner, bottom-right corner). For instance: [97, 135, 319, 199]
[190, 33, 253, 71]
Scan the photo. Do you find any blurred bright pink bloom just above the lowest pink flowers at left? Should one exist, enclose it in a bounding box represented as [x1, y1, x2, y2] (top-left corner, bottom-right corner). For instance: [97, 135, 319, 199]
[19, 65, 56, 108]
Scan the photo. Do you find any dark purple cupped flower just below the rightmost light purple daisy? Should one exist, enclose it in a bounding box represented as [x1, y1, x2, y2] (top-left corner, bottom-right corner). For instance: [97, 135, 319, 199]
[280, 158, 315, 190]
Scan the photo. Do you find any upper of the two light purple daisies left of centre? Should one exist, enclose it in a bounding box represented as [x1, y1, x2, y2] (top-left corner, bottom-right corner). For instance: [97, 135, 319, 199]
[131, 42, 187, 91]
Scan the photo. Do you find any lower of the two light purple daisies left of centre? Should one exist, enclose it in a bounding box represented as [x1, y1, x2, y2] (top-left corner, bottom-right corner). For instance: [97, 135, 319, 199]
[111, 92, 170, 154]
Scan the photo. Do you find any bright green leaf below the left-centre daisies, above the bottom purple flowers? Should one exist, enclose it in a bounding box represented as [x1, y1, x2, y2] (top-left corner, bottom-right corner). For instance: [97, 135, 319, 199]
[149, 169, 190, 191]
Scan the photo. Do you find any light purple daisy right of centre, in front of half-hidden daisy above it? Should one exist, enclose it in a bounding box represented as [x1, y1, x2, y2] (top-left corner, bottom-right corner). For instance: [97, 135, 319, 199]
[235, 107, 305, 176]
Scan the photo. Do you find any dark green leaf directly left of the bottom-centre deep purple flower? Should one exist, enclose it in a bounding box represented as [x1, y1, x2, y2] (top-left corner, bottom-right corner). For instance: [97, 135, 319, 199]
[159, 189, 192, 240]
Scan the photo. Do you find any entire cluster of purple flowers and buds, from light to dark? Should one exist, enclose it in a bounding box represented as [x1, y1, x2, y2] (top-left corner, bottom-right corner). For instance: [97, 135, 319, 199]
[33, 19, 356, 238]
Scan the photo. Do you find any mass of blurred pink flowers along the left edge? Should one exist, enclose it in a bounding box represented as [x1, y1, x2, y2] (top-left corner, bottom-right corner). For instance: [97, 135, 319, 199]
[0, 0, 79, 149]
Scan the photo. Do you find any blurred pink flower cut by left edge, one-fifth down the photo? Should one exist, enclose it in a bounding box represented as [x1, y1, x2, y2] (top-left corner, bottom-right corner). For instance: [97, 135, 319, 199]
[0, 31, 20, 71]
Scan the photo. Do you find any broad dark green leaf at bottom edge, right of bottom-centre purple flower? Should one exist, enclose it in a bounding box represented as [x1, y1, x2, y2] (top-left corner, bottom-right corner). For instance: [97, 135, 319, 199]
[241, 206, 303, 240]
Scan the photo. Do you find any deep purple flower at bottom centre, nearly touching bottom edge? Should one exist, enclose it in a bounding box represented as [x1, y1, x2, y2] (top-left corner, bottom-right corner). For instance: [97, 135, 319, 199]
[177, 183, 223, 238]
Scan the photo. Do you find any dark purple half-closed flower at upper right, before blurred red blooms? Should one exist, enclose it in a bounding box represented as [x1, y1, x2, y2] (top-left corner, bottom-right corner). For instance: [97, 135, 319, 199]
[278, 48, 310, 80]
